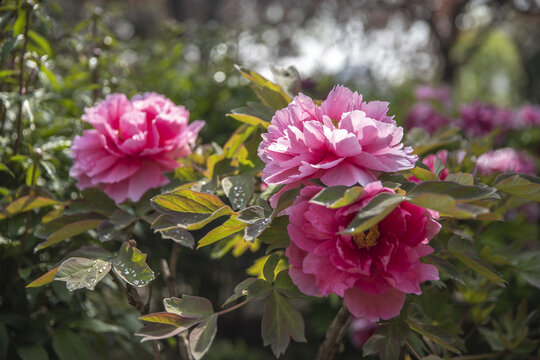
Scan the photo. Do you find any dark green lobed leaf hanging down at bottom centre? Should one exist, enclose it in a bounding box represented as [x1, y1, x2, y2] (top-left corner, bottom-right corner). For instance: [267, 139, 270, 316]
[261, 291, 306, 357]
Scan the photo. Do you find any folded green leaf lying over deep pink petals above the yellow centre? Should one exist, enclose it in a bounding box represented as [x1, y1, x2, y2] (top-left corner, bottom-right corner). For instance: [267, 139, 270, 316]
[341, 192, 405, 235]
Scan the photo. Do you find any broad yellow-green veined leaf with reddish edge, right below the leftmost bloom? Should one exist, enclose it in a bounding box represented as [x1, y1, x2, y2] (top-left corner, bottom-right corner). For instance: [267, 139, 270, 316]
[152, 189, 234, 230]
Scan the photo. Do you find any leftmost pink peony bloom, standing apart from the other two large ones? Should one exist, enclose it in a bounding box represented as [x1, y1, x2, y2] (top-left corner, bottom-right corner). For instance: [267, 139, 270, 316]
[70, 93, 204, 203]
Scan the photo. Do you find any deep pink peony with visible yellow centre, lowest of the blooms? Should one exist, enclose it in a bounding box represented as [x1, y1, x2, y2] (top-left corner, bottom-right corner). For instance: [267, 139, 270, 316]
[286, 181, 441, 321]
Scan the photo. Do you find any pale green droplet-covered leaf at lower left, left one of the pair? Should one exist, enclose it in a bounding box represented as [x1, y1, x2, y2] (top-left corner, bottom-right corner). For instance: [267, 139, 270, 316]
[54, 257, 111, 291]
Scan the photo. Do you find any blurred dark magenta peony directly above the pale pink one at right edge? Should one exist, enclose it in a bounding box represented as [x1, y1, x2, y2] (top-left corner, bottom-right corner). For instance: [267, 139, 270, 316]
[459, 103, 513, 137]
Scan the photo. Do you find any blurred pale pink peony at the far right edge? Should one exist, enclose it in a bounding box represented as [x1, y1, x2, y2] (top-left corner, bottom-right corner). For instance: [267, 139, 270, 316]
[476, 148, 536, 175]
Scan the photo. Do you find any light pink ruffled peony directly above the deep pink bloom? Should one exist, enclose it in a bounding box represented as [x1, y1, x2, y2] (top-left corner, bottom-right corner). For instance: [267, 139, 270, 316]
[259, 86, 417, 185]
